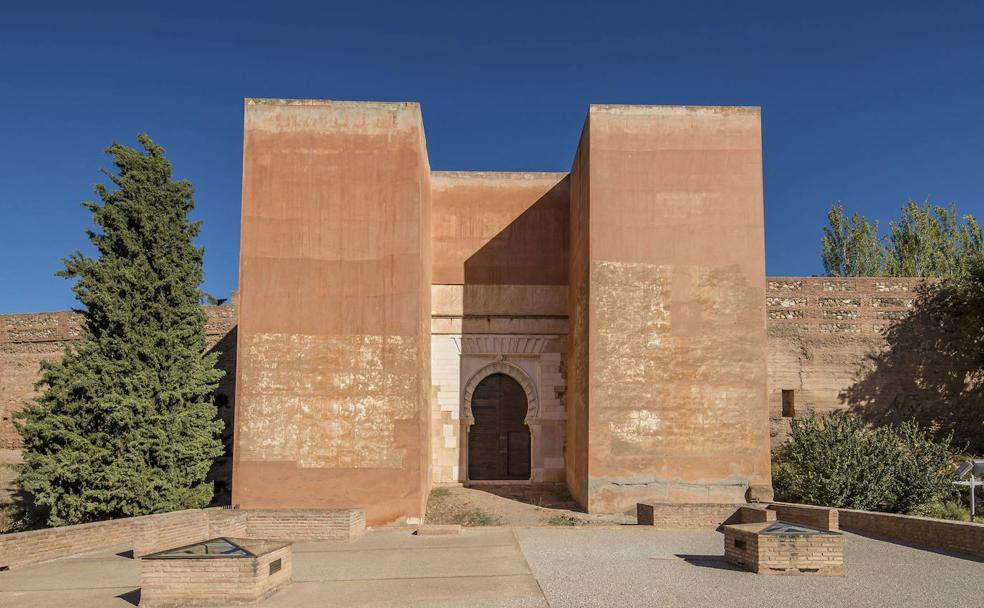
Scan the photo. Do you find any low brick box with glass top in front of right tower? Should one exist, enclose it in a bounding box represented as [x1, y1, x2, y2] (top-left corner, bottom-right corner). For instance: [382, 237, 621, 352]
[721, 522, 844, 576]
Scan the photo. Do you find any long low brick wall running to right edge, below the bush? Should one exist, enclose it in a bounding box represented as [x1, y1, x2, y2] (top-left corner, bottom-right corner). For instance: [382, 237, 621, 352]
[839, 509, 984, 557]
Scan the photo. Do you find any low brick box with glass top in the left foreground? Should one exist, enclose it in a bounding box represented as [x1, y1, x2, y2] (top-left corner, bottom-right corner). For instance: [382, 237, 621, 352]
[140, 538, 291, 608]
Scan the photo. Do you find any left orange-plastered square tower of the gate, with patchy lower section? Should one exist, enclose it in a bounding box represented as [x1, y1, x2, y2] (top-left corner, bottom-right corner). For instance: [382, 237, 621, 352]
[233, 100, 431, 524]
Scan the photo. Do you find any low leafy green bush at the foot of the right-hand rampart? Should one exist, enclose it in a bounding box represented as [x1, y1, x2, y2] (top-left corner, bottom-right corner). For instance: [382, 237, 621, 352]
[773, 413, 958, 513]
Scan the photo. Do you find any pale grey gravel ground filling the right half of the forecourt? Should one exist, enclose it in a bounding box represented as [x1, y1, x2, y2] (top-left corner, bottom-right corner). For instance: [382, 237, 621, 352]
[515, 526, 984, 608]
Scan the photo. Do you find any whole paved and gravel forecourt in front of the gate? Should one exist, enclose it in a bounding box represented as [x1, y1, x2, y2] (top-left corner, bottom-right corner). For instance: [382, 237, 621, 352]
[0, 526, 984, 608]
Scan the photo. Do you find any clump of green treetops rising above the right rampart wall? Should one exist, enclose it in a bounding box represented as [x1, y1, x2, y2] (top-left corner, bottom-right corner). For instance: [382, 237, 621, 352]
[820, 201, 984, 278]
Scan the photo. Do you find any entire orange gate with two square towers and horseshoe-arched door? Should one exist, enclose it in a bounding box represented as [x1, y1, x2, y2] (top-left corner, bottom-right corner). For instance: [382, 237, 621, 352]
[232, 99, 769, 523]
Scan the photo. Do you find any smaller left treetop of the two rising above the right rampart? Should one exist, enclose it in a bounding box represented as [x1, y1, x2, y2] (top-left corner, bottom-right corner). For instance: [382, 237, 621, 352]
[820, 203, 885, 277]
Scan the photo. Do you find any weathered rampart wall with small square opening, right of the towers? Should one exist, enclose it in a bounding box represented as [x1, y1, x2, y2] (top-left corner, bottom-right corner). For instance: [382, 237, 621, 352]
[767, 277, 984, 453]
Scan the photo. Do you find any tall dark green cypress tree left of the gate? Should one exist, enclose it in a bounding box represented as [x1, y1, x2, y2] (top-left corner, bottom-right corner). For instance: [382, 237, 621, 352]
[17, 135, 223, 526]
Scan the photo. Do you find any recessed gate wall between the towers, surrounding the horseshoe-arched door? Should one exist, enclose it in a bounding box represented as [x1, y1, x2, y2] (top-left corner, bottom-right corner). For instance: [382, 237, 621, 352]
[431, 172, 569, 482]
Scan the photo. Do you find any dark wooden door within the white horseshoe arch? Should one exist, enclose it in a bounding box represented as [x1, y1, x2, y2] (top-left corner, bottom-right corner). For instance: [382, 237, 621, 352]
[468, 374, 530, 480]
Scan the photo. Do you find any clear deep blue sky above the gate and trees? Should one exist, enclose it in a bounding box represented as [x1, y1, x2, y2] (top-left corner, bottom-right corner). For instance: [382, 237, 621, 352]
[0, 0, 984, 313]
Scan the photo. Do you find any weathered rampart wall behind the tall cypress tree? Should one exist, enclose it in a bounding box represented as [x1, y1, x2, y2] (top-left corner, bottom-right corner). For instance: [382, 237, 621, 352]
[0, 300, 237, 504]
